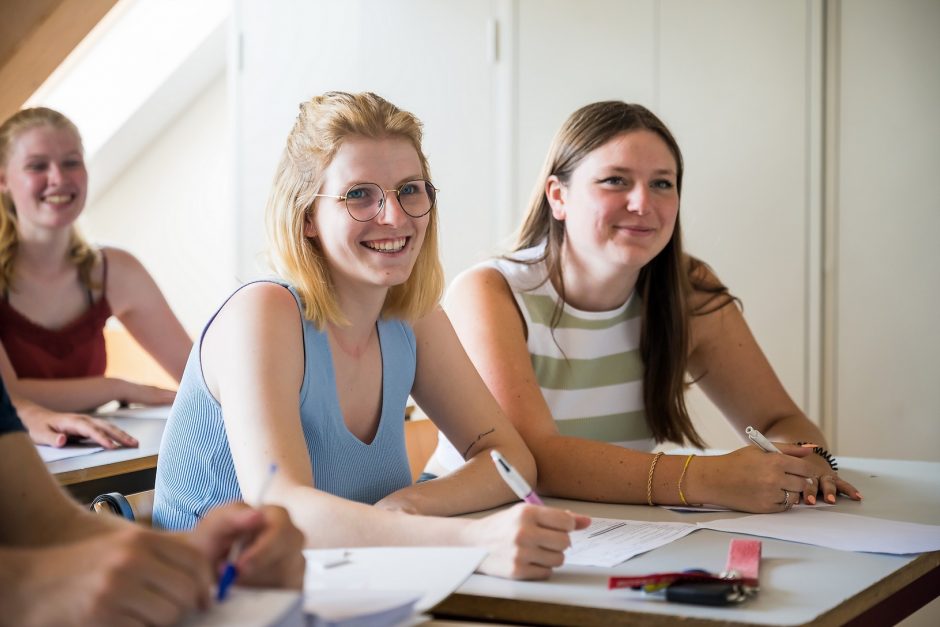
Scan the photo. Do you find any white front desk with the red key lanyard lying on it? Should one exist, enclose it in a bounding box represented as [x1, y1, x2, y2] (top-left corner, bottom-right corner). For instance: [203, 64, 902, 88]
[433, 458, 940, 626]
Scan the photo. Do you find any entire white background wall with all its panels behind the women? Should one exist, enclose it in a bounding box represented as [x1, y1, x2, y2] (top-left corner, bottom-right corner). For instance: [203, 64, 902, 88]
[77, 0, 940, 459]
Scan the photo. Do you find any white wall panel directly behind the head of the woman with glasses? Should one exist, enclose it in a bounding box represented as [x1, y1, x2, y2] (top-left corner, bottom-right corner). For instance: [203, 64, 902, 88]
[234, 0, 500, 284]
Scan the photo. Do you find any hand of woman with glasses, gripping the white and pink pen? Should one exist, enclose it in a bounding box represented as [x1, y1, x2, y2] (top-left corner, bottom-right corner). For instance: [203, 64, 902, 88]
[467, 503, 591, 579]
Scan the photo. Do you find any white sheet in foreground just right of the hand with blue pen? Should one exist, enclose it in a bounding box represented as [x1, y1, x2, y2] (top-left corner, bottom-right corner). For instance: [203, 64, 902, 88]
[304, 547, 486, 612]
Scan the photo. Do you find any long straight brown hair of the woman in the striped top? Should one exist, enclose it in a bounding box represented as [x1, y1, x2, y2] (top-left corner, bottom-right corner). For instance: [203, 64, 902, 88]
[510, 101, 736, 447]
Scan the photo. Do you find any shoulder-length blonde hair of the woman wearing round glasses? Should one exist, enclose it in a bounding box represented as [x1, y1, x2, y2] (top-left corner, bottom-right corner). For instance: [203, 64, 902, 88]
[265, 91, 444, 328]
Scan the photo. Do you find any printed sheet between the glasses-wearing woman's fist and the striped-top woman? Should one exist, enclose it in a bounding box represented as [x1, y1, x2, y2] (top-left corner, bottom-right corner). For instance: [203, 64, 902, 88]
[565, 518, 696, 567]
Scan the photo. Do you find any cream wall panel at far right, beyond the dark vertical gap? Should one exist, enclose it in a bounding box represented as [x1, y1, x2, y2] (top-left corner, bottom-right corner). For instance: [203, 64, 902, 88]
[831, 0, 940, 461]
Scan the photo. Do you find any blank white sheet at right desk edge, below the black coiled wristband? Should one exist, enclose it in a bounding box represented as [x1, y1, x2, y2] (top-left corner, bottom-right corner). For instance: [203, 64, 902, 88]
[697, 507, 940, 555]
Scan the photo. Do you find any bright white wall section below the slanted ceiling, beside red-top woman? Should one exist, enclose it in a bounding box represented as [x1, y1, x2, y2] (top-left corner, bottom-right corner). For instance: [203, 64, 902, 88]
[81, 75, 239, 336]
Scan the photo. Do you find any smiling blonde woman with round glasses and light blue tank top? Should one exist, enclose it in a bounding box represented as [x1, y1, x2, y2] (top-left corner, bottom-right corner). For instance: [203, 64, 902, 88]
[154, 92, 588, 579]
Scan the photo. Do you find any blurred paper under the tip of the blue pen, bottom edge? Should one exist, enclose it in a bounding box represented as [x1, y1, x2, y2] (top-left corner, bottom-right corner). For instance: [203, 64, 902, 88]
[181, 586, 307, 627]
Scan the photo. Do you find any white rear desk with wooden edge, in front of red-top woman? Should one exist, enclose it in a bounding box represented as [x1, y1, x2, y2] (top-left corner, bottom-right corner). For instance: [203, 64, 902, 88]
[46, 418, 166, 502]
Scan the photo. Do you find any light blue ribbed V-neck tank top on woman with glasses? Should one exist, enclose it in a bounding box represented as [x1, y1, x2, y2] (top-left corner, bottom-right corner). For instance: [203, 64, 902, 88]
[153, 283, 416, 529]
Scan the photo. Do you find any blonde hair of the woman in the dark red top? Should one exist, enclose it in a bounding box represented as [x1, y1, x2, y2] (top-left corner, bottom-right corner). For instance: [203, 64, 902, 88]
[0, 107, 98, 293]
